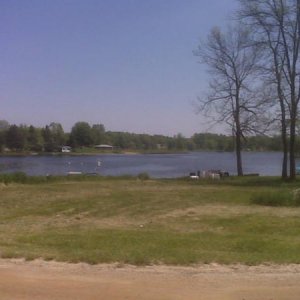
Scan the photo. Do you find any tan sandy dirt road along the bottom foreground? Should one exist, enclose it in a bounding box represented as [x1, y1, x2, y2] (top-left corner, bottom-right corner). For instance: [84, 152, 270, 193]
[0, 259, 300, 300]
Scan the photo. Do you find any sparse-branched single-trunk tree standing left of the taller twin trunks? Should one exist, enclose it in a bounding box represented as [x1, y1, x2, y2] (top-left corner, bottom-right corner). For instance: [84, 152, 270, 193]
[194, 24, 262, 176]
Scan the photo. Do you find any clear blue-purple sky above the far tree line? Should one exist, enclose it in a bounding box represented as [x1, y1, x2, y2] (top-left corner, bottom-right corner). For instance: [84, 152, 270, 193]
[0, 0, 237, 137]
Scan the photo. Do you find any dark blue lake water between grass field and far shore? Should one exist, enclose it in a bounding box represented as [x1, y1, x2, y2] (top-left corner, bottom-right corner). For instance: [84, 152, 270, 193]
[0, 152, 288, 178]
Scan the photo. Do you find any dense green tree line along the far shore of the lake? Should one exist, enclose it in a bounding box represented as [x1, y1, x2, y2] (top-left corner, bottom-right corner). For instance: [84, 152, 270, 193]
[0, 120, 292, 153]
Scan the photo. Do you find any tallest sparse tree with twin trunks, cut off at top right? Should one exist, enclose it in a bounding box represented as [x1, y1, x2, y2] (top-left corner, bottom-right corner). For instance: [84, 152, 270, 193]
[239, 0, 300, 179]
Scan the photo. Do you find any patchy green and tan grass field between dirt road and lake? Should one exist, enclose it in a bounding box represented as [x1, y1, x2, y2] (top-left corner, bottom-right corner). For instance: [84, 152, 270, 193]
[0, 176, 300, 265]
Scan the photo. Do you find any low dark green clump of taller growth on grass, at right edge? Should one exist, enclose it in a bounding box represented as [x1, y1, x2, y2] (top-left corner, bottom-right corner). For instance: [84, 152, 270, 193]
[251, 190, 300, 206]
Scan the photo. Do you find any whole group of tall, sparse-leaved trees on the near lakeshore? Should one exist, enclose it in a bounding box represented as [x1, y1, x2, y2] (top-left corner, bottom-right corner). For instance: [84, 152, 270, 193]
[194, 0, 300, 179]
